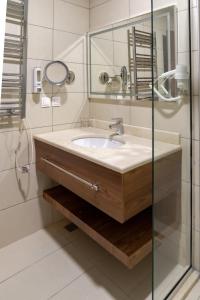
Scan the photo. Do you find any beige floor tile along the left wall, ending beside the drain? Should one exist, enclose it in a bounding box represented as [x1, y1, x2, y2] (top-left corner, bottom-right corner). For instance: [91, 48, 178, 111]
[0, 221, 76, 282]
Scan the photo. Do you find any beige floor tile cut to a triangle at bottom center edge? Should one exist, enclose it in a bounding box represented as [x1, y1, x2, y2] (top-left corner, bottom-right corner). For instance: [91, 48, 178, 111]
[50, 268, 128, 300]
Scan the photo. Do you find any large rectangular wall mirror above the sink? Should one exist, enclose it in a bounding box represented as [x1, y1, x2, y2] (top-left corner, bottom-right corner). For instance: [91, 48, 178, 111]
[88, 6, 177, 100]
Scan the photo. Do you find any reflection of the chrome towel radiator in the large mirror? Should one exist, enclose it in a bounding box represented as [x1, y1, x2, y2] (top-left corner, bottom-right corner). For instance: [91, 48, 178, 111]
[127, 26, 157, 100]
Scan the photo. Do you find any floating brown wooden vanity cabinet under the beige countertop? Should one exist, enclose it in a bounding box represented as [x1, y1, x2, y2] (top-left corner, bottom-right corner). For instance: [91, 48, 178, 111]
[35, 140, 181, 223]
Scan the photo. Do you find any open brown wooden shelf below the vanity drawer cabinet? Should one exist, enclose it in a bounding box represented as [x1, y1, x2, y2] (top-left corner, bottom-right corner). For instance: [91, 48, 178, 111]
[44, 186, 152, 269]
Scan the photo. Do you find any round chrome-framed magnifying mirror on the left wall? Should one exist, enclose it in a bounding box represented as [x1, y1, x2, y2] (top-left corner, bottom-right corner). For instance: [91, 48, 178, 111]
[44, 60, 70, 85]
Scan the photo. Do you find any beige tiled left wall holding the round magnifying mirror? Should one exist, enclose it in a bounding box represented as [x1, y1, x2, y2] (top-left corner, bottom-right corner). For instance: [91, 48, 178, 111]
[0, 0, 89, 247]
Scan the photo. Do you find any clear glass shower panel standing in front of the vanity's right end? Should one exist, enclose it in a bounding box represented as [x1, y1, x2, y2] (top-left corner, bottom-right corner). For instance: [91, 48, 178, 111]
[152, 0, 192, 300]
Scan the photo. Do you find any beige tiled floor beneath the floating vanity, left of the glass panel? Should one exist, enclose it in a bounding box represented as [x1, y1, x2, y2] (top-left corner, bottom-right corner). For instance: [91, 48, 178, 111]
[0, 221, 151, 300]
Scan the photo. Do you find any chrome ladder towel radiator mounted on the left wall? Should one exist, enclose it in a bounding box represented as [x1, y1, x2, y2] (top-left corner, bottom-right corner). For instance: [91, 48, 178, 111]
[0, 0, 27, 119]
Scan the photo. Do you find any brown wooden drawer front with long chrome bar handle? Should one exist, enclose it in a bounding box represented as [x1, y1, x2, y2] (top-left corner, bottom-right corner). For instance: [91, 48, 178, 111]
[35, 141, 124, 222]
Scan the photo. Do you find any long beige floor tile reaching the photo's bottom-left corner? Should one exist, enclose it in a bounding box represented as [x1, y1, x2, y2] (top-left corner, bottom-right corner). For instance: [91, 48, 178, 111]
[0, 245, 92, 300]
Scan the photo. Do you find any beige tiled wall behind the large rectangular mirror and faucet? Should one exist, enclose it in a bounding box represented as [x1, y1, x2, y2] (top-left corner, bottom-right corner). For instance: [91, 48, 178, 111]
[90, 0, 200, 270]
